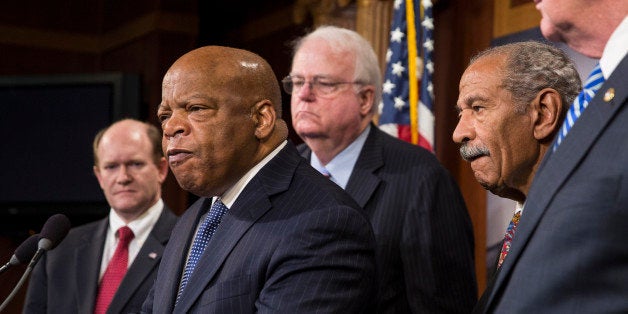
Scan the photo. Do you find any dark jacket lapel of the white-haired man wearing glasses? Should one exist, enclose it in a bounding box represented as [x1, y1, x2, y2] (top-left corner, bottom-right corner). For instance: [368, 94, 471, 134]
[346, 124, 384, 208]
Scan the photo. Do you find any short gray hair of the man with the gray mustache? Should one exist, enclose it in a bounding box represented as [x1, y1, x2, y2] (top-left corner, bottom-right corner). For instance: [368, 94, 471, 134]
[469, 41, 582, 114]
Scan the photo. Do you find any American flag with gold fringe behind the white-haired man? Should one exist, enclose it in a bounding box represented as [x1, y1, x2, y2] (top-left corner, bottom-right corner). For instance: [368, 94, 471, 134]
[379, 0, 434, 152]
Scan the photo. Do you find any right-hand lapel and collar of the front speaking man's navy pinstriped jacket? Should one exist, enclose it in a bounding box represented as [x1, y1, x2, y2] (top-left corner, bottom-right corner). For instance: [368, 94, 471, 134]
[175, 143, 302, 313]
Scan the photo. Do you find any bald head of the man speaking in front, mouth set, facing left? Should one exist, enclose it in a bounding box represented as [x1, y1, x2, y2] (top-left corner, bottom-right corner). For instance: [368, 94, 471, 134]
[162, 46, 288, 197]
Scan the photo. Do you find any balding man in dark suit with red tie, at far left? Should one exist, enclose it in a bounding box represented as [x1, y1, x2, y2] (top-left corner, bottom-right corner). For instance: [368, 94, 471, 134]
[24, 119, 177, 313]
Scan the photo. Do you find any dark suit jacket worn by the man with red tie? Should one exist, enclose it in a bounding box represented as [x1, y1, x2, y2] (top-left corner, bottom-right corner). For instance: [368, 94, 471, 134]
[24, 207, 177, 314]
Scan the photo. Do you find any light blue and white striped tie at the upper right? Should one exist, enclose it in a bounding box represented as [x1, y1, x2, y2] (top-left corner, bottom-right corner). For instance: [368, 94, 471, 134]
[552, 63, 604, 151]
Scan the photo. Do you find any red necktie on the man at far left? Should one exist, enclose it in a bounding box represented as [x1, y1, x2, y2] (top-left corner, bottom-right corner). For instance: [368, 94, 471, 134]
[94, 226, 134, 314]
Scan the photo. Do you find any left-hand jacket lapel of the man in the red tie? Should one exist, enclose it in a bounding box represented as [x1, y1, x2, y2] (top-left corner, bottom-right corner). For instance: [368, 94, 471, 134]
[76, 218, 109, 313]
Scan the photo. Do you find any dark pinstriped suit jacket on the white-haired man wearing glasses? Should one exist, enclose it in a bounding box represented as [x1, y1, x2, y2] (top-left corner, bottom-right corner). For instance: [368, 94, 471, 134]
[299, 125, 477, 313]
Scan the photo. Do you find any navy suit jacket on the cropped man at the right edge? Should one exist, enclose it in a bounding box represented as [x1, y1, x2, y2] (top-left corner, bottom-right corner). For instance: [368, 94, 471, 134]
[475, 57, 628, 313]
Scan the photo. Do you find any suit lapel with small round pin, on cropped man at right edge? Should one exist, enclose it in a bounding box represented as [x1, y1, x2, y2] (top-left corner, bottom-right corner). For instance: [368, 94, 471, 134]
[488, 57, 628, 307]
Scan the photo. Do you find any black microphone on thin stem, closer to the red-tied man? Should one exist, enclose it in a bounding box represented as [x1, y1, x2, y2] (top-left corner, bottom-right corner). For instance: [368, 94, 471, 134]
[0, 214, 70, 313]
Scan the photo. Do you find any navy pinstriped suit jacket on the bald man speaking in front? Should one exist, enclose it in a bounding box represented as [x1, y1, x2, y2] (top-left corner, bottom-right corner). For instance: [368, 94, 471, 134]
[143, 143, 375, 314]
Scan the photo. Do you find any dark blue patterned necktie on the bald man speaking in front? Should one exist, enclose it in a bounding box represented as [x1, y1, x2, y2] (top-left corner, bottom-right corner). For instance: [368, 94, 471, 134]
[175, 199, 228, 304]
